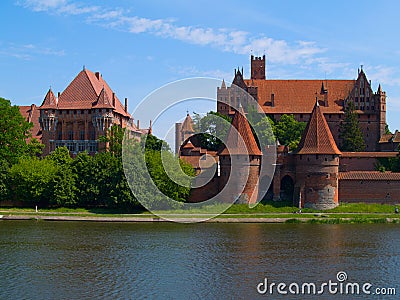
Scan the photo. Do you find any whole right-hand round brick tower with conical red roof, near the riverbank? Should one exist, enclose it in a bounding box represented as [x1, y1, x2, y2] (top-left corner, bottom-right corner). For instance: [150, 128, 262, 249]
[295, 102, 341, 209]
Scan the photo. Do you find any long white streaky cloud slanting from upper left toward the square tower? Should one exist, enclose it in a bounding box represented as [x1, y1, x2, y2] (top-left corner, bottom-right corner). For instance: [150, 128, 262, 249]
[20, 0, 325, 64]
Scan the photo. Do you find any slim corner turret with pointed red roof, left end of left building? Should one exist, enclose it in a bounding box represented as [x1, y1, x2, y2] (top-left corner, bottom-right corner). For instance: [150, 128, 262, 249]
[39, 88, 58, 155]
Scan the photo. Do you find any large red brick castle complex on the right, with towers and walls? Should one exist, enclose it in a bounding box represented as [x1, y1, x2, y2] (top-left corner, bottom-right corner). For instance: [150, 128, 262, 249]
[175, 55, 400, 209]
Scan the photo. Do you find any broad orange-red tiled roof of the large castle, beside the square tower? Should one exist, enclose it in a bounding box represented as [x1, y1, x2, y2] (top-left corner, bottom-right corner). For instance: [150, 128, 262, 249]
[245, 79, 356, 114]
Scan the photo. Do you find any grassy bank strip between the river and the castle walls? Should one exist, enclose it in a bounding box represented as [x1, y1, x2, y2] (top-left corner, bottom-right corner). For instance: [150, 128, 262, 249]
[0, 201, 400, 224]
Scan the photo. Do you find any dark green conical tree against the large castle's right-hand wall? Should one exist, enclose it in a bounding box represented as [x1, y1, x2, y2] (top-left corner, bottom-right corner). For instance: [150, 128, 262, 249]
[340, 102, 365, 152]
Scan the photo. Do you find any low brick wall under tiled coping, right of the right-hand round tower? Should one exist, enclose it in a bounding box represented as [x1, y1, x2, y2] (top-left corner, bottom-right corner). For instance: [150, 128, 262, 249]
[339, 179, 400, 204]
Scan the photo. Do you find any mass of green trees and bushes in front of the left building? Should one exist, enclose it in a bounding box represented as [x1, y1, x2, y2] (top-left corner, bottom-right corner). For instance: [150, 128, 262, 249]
[0, 98, 194, 210]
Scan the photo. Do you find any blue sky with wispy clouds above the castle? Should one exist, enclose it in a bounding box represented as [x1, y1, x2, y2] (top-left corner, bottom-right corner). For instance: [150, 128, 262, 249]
[0, 0, 400, 140]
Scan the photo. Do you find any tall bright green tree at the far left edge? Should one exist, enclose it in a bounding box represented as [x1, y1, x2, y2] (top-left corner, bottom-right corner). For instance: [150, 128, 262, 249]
[0, 98, 33, 165]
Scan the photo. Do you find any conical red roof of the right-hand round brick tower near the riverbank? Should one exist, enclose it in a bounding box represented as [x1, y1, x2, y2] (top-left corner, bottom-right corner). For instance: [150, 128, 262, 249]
[297, 102, 341, 155]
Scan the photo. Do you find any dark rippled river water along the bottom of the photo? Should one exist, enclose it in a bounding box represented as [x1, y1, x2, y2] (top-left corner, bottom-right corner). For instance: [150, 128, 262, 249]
[0, 221, 400, 299]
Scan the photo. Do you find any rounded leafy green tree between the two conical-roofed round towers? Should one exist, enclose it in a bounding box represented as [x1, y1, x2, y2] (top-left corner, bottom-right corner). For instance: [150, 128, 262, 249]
[273, 114, 307, 150]
